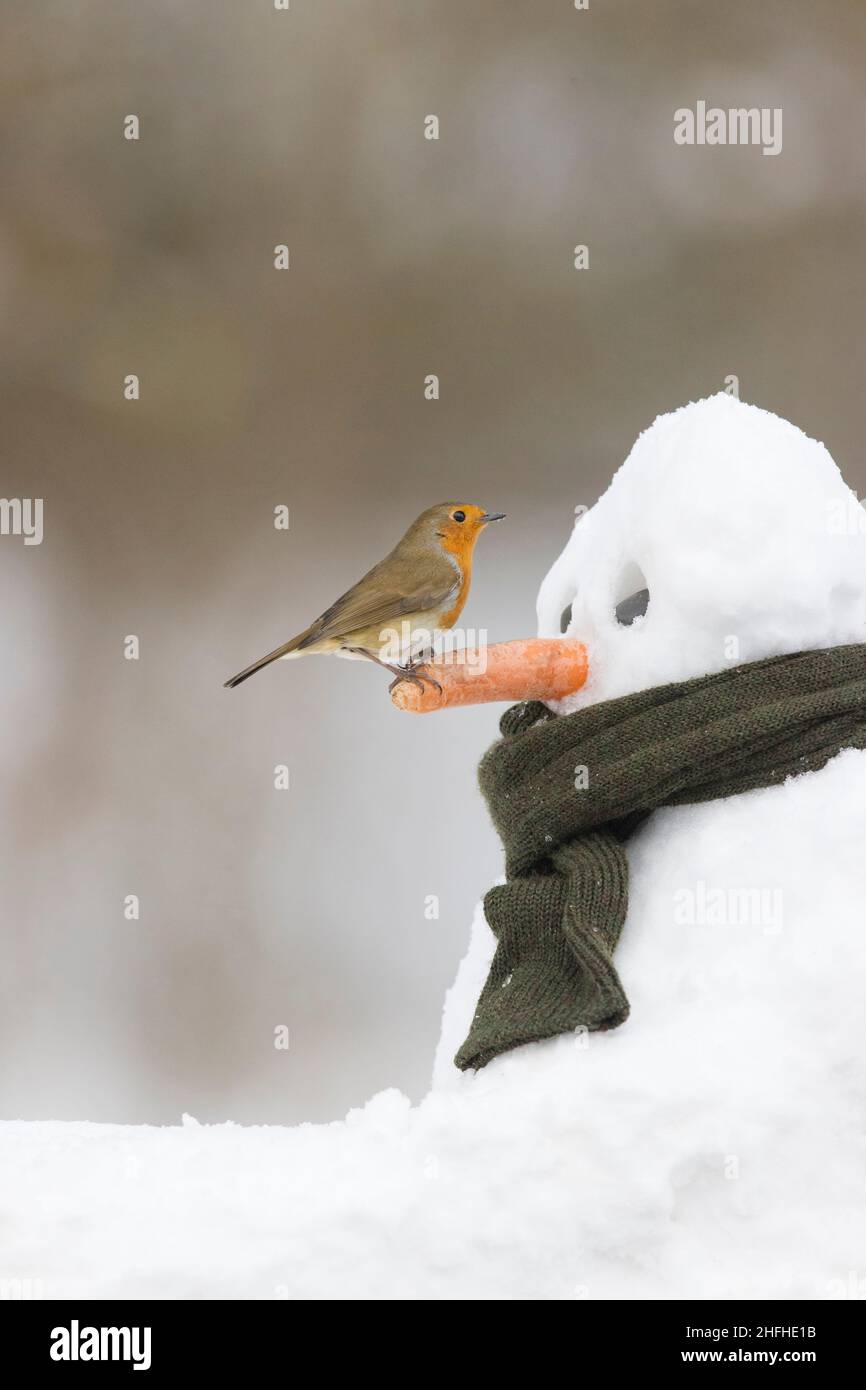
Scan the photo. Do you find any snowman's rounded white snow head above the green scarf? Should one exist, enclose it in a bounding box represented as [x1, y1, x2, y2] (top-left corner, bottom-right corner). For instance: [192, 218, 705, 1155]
[538, 393, 866, 713]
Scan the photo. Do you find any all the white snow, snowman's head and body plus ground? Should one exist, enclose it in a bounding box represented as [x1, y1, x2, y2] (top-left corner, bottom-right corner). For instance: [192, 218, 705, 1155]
[0, 396, 866, 1300]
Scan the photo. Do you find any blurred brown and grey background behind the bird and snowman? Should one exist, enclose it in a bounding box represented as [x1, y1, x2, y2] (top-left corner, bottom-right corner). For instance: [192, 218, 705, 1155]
[0, 0, 866, 1123]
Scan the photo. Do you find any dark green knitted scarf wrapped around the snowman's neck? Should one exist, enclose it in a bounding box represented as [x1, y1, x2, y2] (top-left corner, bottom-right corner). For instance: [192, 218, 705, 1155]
[455, 645, 866, 1069]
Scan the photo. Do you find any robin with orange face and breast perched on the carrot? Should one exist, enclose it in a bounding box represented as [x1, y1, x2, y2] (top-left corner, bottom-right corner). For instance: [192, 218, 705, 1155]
[225, 502, 505, 689]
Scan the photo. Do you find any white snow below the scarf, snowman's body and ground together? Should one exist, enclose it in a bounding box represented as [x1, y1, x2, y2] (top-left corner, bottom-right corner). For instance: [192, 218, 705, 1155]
[6, 752, 866, 1298]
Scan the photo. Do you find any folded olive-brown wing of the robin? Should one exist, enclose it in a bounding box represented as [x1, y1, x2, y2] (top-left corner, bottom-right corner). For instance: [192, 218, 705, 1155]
[300, 560, 460, 648]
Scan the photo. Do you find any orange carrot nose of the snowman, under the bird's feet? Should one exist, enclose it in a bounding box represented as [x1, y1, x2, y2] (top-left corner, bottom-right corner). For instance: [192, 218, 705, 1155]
[391, 637, 588, 714]
